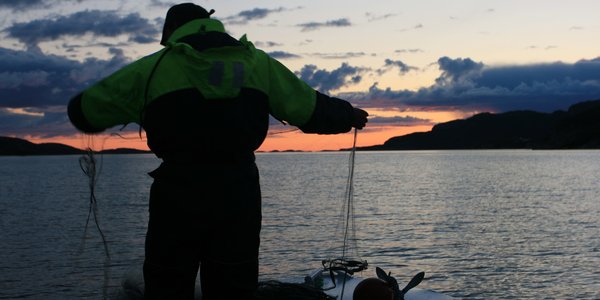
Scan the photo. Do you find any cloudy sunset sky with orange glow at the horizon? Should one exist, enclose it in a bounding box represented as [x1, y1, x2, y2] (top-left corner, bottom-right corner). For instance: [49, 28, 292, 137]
[0, 0, 600, 151]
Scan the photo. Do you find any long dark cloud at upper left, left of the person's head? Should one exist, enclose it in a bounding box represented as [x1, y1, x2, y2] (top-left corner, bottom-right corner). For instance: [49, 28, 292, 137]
[4, 10, 160, 48]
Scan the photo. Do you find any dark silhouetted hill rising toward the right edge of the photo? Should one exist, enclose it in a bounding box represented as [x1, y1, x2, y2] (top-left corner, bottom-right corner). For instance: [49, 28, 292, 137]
[360, 100, 600, 150]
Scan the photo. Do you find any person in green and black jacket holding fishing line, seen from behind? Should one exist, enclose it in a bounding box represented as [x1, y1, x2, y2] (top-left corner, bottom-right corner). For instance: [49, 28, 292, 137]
[69, 3, 368, 299]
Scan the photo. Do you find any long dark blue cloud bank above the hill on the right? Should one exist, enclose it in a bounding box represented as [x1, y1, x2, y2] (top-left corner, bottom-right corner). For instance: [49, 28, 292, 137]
[341, 57, 600, 112]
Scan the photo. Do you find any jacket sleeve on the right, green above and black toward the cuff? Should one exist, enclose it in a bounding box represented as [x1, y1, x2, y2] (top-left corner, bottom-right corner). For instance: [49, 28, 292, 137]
[262, 53, 353, 134]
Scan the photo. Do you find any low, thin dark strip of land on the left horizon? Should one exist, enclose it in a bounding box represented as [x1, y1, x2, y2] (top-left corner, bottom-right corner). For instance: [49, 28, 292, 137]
[0, 136, 150, 156]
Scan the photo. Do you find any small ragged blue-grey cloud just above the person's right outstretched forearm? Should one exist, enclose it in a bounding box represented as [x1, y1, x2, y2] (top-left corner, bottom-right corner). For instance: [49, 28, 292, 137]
[297, 63, 366, 93]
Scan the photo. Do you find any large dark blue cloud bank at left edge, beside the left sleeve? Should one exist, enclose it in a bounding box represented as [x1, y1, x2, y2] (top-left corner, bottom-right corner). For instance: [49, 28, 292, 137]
[0, 48, 128, 137]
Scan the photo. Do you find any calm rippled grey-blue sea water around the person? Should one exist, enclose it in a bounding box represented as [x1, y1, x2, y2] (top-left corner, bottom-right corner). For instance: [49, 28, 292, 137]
[0, 150, 600, 299]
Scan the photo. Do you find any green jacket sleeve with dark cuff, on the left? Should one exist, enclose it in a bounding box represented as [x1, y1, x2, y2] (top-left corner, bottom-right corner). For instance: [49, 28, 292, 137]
[68, 56, 146, 133]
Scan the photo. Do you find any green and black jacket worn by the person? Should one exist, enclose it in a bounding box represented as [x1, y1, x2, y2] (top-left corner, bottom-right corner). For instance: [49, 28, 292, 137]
[69, 19, 353, 161]
